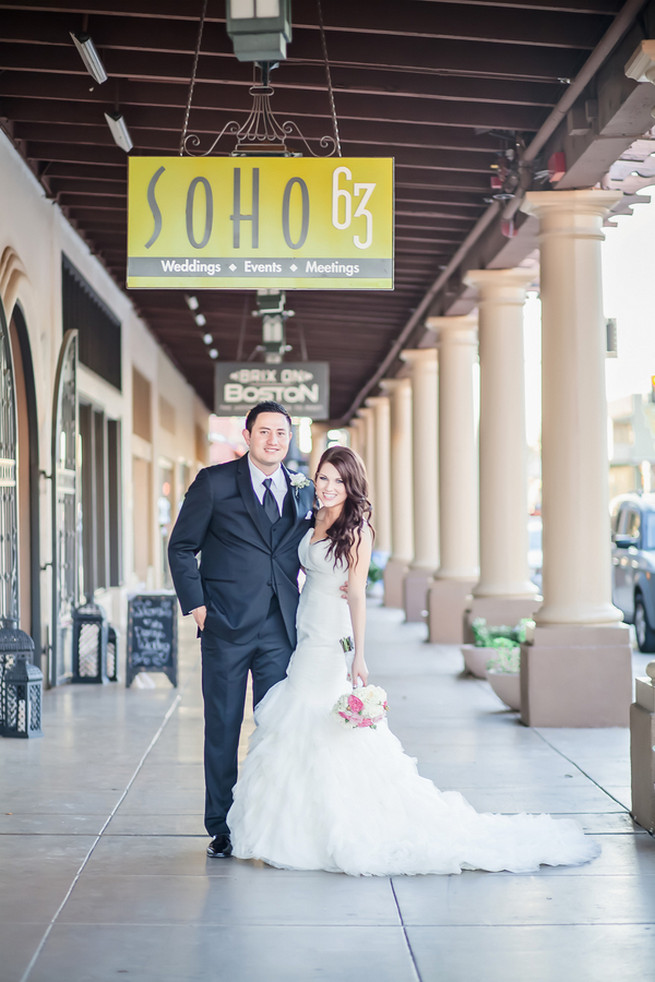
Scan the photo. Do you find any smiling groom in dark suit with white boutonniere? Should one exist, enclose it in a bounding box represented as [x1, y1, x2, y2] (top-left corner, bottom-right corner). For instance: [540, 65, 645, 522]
[168, 402, 314, 858]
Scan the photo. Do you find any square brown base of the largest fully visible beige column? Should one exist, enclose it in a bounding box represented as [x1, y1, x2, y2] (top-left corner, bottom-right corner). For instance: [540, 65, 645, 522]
[521, 625, 632, 727]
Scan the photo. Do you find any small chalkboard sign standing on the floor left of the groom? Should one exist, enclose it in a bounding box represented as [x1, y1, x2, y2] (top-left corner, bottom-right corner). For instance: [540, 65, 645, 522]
[125, 592, 177, 687]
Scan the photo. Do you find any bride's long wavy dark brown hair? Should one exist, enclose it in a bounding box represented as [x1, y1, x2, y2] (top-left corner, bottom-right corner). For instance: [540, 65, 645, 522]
[314, 446, 375, 566]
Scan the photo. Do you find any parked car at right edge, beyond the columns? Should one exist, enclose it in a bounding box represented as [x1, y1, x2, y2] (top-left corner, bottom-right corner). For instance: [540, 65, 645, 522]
[611, 494, 655, 651]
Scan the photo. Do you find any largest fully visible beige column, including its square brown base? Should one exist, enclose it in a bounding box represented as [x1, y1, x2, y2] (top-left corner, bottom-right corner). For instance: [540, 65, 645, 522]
[521, 190, 632, 726]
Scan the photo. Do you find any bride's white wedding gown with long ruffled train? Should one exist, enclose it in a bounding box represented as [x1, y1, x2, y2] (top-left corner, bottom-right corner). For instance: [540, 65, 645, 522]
[227, 529, 599, 876]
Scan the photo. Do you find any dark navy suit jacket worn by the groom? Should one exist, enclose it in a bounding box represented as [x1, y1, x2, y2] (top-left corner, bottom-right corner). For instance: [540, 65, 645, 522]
[168, 456, 314, 647]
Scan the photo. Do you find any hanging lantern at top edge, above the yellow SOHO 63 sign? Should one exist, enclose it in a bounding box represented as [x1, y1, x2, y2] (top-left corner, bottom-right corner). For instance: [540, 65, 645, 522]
[227, 0, 291, 62]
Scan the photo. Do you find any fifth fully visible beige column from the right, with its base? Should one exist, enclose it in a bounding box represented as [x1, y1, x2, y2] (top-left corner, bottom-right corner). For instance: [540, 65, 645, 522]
[380, 378, 414, 607]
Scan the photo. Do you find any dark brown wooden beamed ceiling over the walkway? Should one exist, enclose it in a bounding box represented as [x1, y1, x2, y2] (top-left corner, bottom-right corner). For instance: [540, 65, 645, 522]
[0, 0, 640, 420]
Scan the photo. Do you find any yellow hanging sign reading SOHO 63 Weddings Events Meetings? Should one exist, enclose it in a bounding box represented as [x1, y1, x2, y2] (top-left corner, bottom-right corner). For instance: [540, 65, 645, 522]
[127, 157, 393, 290]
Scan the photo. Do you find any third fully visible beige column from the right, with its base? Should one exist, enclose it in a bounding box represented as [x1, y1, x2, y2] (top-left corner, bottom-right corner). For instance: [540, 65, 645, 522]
[425, 315, 479, 644]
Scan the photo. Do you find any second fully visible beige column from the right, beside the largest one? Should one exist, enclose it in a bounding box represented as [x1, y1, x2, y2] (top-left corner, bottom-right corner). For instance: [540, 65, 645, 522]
[465, 269, 539, 624]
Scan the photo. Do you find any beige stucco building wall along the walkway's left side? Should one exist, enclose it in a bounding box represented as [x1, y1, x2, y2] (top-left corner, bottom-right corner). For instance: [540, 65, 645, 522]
[0, 134, 208, 668]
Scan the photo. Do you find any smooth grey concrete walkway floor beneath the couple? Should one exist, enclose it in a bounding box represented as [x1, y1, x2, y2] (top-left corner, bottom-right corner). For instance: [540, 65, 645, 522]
[0, 607, 655, 982]
